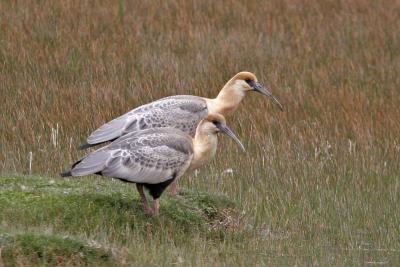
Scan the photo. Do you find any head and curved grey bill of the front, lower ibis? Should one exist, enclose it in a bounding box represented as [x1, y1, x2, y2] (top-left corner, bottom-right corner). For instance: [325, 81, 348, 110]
[196, 113, 245, 151]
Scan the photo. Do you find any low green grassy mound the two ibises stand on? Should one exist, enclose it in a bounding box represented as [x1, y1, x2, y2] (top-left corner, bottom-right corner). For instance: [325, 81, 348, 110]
[0, 176, 240, 265]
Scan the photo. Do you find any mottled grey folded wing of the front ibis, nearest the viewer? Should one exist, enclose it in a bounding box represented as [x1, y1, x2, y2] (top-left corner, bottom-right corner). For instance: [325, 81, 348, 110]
[71, 128, 193, 184]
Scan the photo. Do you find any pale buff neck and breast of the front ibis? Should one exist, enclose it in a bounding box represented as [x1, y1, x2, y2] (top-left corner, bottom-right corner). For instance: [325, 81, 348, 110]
[189, 127, 218, 171]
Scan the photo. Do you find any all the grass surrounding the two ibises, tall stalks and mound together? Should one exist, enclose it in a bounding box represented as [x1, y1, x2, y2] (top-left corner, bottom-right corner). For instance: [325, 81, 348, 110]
[0, 0, 400, 266]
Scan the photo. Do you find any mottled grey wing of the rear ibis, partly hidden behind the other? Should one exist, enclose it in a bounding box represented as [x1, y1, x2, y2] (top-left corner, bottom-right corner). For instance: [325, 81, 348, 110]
[84, 95, 208, 147]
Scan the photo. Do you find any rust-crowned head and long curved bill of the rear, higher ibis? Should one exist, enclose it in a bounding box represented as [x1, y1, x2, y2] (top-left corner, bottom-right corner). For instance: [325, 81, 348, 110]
[226, 71, 283, 110]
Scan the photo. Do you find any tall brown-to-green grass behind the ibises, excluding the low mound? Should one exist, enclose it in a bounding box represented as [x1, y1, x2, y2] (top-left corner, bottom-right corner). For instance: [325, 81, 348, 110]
[0, 0, 400, 262]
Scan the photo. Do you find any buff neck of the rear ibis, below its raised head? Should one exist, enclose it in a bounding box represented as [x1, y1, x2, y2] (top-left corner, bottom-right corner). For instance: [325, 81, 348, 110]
[206, 83, 245, 117]
